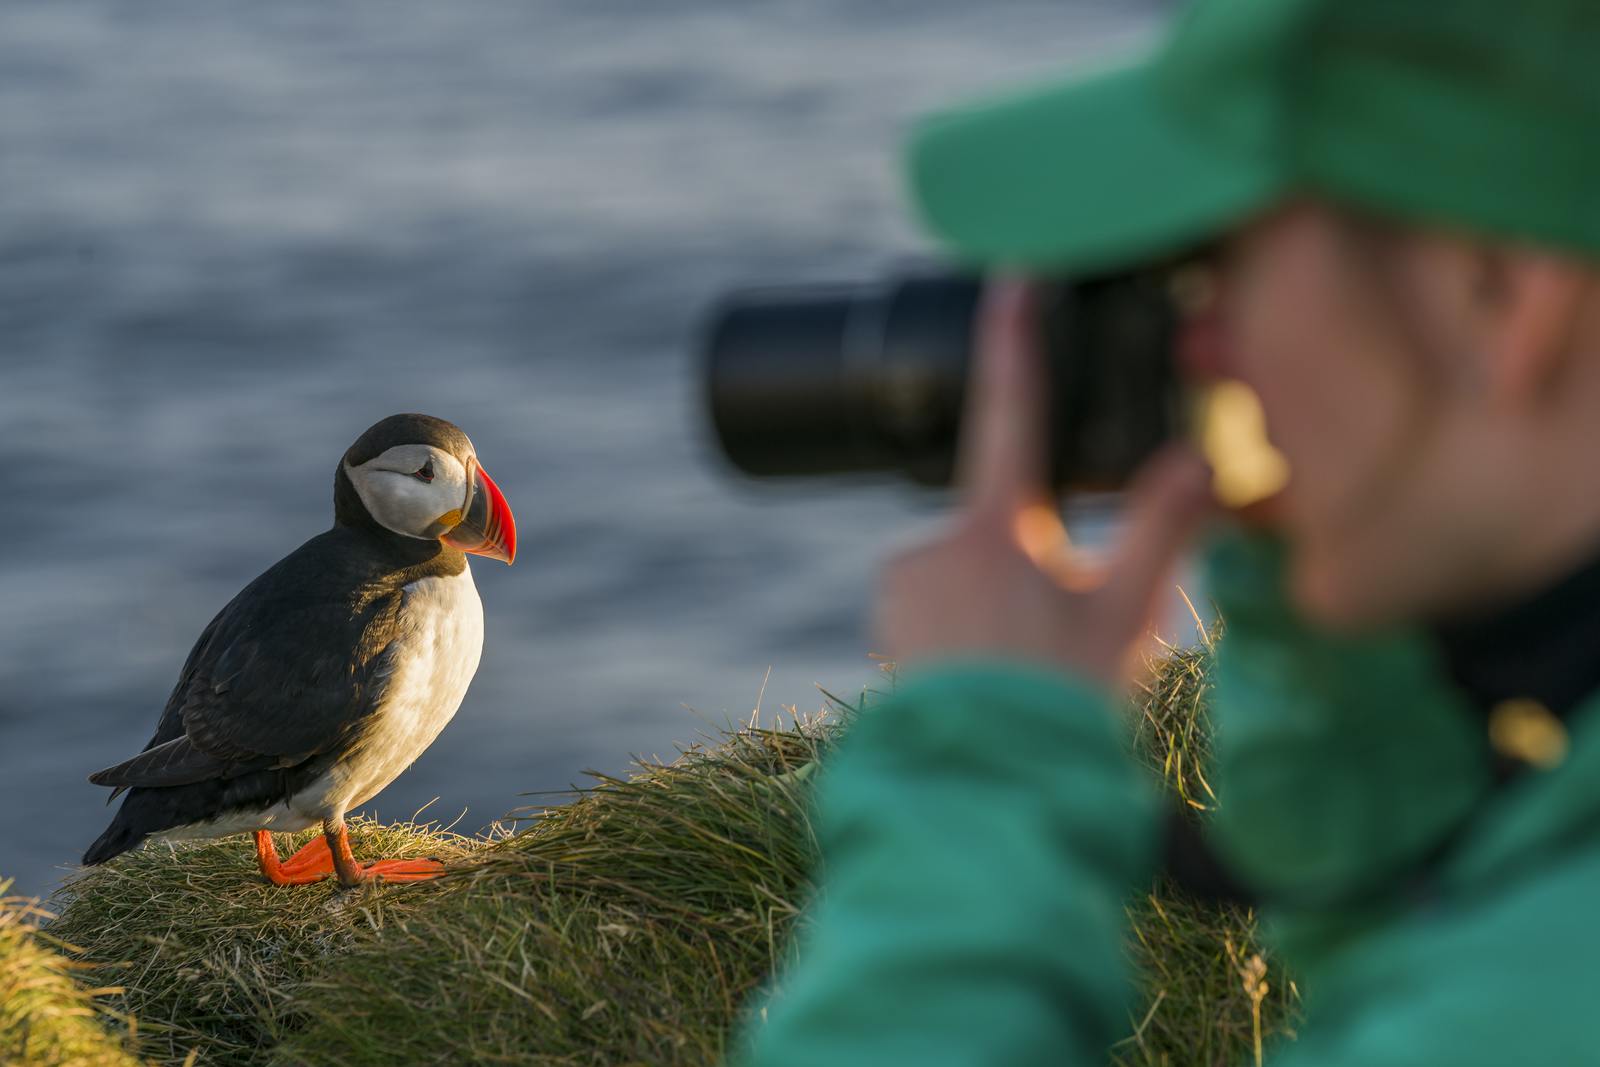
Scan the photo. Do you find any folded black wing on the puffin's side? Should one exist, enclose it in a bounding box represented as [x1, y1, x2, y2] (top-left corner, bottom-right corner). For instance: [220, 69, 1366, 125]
[90, 530, 411, 789]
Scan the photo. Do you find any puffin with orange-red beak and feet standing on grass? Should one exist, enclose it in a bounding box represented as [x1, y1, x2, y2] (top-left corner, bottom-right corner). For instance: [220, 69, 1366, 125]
[83, 414, 517, 886]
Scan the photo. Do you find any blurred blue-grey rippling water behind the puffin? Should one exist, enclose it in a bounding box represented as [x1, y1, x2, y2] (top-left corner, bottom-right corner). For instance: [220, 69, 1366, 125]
[0, 0, 1165, 893]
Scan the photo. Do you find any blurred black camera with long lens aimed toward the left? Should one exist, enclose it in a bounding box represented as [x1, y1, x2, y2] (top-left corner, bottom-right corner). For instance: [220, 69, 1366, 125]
[704, 269, 1184, 491]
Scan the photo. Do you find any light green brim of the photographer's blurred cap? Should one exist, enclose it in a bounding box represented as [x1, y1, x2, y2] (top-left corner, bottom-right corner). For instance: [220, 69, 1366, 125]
[909, 56, 1283, 272]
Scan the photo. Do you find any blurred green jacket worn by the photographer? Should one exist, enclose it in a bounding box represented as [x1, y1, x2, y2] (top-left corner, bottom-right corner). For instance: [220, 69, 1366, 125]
[742, 537, 1600, 1067]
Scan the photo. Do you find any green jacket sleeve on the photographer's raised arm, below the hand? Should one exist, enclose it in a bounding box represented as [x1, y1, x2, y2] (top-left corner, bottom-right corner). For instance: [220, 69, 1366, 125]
[736, 664, 1158, 1067]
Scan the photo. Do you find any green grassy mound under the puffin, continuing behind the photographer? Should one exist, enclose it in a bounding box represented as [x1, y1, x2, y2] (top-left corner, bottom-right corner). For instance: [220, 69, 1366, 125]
[28, 649, 1298, 1067]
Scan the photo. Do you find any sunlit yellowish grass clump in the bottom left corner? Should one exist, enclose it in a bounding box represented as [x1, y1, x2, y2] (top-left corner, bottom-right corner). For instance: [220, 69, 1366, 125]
[0, 881, 138, 1067]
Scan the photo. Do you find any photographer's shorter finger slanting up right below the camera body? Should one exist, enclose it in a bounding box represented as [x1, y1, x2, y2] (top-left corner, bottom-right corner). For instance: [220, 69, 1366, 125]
[1096, 445, 1213, 627]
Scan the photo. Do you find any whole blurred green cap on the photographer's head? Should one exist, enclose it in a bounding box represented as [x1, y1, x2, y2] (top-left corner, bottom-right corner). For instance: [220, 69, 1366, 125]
[910, 0, 1600, 270]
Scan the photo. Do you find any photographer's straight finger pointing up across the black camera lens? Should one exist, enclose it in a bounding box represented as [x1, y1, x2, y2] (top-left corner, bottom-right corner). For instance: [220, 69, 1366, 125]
[958, 278, 1048, 522]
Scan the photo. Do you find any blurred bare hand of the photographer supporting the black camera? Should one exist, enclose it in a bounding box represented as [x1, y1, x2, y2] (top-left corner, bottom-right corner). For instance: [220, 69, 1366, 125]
[877, 280, 1211, 683]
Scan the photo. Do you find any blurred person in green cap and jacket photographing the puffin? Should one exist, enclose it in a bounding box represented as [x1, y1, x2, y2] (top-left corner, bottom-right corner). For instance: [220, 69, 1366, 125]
[736, 0, 1600, 1067]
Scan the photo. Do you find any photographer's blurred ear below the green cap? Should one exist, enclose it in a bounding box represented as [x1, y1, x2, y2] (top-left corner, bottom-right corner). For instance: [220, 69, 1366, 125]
[1480, 248, 1589, 406]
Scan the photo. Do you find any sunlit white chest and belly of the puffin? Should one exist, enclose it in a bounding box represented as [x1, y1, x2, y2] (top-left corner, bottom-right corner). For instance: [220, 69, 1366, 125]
[330, 566, 483, 814]
